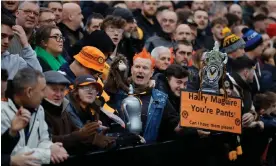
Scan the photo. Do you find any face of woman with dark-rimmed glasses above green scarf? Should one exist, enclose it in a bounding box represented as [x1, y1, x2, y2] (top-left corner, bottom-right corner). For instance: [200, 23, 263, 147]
[45, 29, 63, 55]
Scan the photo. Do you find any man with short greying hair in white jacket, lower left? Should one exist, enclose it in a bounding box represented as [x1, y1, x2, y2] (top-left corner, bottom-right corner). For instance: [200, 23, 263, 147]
[1, 68, 68, 164]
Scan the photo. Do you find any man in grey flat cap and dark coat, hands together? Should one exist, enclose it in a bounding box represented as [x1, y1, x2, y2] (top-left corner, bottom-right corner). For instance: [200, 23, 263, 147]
[42, 71, 114, 154]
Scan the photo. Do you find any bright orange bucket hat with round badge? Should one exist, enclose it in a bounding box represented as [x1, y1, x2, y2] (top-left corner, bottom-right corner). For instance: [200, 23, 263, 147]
[74, 46, 105, 73]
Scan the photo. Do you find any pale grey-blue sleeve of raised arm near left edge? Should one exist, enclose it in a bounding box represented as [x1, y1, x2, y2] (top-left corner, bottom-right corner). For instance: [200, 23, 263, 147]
[19, 45, 42, 72]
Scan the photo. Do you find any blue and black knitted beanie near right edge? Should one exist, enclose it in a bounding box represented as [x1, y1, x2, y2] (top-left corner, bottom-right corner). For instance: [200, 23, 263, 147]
[242, 28, 263, 52]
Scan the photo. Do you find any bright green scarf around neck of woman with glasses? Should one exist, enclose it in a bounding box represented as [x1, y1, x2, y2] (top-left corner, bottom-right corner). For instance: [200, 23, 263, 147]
[35, 46, 66, 71]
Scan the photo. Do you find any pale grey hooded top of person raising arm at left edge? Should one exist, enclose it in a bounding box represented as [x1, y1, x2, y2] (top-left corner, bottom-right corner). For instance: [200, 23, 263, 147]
[1, 45, 42, 80]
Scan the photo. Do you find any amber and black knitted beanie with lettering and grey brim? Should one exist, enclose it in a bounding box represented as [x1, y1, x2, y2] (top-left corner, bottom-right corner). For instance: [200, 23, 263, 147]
[221, 27, 245, 53]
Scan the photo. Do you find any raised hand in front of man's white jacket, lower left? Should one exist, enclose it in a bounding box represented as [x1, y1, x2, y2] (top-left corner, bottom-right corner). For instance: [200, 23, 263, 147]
[10, 106, 31, 136]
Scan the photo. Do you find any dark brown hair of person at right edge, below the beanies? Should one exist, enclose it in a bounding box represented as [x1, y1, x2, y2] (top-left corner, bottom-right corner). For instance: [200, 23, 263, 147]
[253, 92, 276, 112]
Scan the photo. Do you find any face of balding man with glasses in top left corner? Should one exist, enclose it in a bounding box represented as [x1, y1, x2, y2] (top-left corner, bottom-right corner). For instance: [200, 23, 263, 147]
[16, 1, 39, 29]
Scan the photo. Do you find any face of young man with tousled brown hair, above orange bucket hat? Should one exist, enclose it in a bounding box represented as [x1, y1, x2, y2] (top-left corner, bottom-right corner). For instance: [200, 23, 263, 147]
[104, 25, 124, 46]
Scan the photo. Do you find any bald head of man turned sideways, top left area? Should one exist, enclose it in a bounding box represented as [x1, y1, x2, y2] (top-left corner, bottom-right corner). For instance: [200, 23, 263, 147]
[62, 3, 83, 30]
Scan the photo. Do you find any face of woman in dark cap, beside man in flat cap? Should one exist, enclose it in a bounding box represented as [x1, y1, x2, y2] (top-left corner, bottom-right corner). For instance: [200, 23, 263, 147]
[78, 84, 98, 104]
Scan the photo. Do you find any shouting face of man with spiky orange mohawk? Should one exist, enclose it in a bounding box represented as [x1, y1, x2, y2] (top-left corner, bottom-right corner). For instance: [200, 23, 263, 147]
[131, 58, 153, 87]
